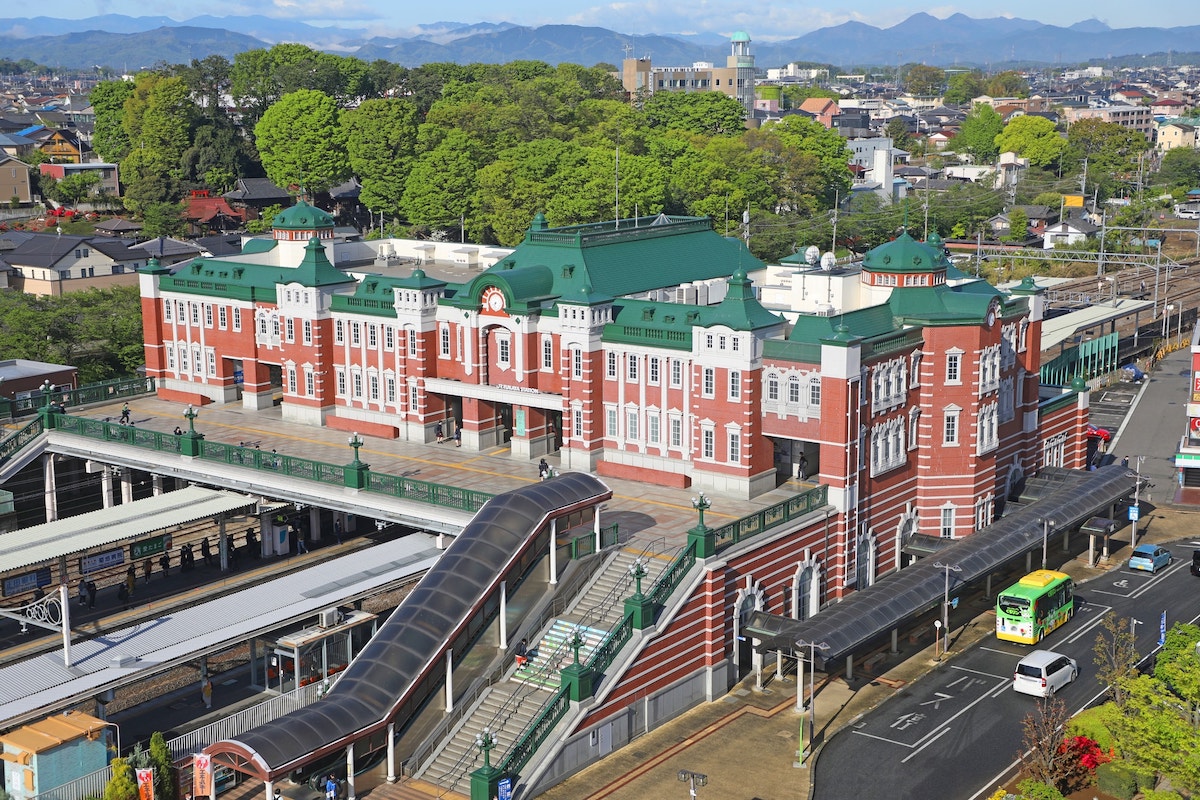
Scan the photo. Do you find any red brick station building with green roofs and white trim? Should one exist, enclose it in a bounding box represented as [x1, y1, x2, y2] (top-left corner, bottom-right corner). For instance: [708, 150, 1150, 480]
[140, 201, 1088, 604]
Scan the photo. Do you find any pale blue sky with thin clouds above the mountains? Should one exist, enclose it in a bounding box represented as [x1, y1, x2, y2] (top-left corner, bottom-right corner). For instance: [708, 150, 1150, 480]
[63, 0, 1200, 41]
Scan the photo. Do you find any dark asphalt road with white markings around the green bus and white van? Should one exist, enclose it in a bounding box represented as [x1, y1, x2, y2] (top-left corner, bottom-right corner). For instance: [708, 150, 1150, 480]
[814, 556, 1200, 800]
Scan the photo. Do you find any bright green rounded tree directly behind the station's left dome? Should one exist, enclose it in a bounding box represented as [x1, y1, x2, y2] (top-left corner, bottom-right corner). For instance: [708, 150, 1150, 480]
[254, 89, 350, 194]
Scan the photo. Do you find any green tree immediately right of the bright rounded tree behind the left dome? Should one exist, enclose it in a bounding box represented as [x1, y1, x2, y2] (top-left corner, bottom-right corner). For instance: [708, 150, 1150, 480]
[342, 100, 416, 215]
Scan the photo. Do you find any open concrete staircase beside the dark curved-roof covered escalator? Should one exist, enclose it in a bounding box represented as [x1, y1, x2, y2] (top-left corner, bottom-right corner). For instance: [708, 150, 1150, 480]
[416, 547, 673, 795]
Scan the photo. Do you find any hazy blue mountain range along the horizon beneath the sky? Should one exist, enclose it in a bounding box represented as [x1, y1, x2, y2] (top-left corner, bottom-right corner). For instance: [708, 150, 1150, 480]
[0, 13, 1200, 71]
